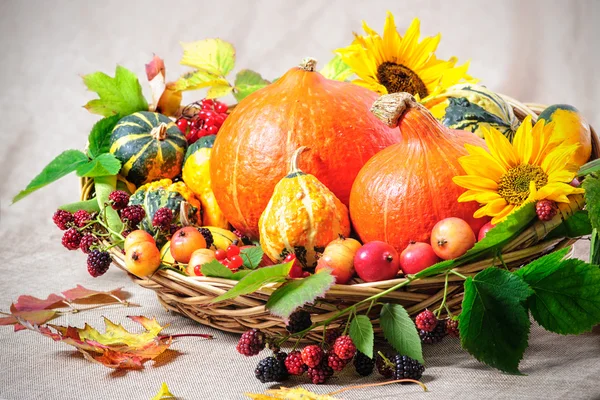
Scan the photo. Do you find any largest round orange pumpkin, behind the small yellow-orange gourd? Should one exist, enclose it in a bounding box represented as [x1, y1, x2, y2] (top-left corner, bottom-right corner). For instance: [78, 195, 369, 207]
[210, 59, 400, 238]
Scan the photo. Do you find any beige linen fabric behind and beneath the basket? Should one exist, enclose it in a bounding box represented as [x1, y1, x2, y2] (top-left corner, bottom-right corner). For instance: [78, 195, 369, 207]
[0, 0, 600, 400]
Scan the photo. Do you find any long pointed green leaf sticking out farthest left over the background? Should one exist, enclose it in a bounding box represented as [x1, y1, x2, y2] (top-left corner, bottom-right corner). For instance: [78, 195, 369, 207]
[12, 150, 88, 203]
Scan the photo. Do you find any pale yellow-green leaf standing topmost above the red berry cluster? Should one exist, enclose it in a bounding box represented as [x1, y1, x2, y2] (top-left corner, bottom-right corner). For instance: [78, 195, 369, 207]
[180, 39, 235, 77]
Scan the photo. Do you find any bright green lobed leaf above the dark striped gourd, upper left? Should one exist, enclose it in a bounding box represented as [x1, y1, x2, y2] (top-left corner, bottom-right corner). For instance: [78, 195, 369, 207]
[83, 65, 148, 117]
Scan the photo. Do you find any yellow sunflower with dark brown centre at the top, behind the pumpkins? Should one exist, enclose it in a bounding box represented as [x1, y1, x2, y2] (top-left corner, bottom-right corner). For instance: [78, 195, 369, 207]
[335, 11, 477, 101]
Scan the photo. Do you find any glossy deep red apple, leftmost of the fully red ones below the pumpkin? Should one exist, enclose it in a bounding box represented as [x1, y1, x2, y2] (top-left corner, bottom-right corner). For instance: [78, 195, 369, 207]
[354, 241, 400, 282]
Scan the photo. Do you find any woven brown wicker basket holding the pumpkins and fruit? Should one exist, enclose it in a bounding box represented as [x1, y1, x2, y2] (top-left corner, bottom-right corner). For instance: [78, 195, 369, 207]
[81, 96, 600, 341]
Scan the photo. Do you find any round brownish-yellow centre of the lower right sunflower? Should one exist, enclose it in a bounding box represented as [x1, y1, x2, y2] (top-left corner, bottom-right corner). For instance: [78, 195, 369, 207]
[498, 164, 548, 205]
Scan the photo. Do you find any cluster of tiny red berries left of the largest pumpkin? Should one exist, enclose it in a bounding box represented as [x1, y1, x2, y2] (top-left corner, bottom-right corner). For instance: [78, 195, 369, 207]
[177, 99, 228, 144]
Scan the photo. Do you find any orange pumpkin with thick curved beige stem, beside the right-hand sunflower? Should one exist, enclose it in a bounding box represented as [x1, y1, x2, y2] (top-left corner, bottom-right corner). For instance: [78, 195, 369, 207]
[350, 93, 487, 251]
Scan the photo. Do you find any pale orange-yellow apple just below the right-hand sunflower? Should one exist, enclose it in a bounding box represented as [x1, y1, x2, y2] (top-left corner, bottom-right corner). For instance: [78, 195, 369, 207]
[431, 217, 475, 260]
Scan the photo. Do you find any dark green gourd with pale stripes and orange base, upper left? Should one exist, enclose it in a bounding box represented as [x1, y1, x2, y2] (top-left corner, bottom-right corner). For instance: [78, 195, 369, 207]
[110, 111, 187, 186]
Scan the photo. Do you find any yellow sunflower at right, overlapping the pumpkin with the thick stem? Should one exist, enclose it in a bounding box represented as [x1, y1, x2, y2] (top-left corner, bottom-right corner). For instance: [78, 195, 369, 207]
[452, 117, 584, 224]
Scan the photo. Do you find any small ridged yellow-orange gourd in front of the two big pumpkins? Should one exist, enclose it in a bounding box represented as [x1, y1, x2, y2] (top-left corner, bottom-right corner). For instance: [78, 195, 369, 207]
[258, 147, 350, 268]
